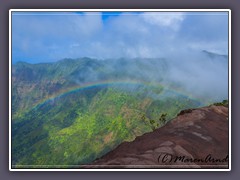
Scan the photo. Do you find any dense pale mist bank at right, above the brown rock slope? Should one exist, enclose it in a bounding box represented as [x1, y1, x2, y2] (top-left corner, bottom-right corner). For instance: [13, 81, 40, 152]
[165, 51, 228, 102]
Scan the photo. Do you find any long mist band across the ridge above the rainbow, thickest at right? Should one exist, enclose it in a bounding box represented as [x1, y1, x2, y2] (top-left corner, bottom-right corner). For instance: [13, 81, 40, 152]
[67, 48, 228, 103]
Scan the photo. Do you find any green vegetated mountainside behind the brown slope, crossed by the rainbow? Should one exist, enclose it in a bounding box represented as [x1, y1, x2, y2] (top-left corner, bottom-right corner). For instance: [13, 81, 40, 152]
[12, 58, 225, 168]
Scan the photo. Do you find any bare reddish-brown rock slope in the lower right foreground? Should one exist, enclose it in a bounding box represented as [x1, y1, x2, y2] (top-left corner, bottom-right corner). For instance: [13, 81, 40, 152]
[88, 105, 229, 168]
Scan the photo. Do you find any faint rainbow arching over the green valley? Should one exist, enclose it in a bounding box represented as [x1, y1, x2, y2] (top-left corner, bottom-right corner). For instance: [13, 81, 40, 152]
[33, 80, 200, 108]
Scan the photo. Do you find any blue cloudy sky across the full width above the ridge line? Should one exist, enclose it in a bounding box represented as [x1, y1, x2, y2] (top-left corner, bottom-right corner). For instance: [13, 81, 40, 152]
[12, 12, 228, 63]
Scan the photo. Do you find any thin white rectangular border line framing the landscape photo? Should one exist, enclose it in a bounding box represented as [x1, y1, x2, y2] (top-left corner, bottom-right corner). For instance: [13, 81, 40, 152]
[9, 9, 232, 171]
